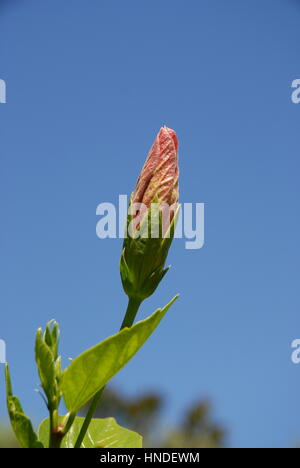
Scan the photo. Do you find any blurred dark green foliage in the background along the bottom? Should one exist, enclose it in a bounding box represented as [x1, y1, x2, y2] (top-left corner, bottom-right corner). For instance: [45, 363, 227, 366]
[0, 388, 226, 448]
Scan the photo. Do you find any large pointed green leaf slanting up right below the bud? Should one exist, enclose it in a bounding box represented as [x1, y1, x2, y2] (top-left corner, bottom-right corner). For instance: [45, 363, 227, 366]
[62, 296, 178, 413]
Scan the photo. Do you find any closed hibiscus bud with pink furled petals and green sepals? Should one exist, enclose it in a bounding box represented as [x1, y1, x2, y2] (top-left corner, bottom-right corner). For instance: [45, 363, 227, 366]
[120, 127, 179, 302]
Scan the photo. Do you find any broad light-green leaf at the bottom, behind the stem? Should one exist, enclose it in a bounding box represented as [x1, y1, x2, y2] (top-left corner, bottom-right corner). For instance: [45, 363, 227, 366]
[39, 416, 143, 448]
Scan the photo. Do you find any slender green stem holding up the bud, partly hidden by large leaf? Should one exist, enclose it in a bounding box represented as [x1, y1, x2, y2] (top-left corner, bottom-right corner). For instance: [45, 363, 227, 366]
[74, 297, 142, 448]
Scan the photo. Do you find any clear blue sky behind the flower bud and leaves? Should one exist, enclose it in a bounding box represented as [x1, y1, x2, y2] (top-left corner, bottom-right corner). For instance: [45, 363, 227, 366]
[0, 0, 300, 447]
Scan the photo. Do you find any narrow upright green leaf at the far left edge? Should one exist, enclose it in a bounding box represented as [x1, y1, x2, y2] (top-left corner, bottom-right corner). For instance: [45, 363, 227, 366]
[5, 365, 44, 448]
